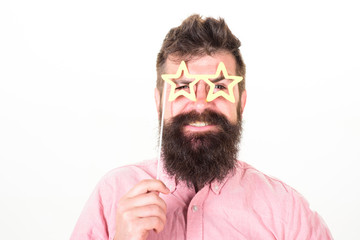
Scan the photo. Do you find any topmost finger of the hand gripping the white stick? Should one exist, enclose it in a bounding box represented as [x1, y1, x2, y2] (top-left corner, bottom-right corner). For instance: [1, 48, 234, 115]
[126, 179, 170, 197]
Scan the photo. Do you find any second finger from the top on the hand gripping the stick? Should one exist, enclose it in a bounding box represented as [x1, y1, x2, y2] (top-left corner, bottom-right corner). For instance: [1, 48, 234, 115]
[121, 192, 166, 212]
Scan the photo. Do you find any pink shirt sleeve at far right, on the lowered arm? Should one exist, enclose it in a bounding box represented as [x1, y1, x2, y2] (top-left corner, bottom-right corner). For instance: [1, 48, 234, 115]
[285, 190, 333, 240]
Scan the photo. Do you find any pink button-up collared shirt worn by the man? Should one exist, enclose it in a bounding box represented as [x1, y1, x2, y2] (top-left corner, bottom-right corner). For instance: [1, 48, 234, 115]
[71, 160, 332, 240]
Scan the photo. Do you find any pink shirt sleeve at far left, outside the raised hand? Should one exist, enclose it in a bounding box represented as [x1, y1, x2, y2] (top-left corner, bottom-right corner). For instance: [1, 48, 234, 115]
[70, 180, 109, 240]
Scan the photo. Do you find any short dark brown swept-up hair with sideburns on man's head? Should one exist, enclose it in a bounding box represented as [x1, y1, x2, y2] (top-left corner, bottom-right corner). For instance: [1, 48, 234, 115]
[156, 14, 246, 96]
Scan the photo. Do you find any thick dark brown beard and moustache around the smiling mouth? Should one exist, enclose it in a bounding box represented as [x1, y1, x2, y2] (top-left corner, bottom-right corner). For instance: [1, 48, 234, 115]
[162, 110, 241, 189]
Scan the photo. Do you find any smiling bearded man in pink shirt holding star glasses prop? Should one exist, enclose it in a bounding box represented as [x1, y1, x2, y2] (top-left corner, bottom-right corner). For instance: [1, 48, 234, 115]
[71, 15, 332, 240]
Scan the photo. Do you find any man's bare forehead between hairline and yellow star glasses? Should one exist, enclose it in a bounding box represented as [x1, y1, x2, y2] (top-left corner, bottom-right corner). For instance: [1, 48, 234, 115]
[164, 52, 236, 75]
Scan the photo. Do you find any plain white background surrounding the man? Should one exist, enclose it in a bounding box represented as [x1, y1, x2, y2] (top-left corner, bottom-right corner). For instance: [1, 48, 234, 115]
[0, 0, 360, 240]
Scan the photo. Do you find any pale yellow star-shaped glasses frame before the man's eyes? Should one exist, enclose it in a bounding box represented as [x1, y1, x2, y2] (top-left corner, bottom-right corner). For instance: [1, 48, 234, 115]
[161, 61, 243, 103]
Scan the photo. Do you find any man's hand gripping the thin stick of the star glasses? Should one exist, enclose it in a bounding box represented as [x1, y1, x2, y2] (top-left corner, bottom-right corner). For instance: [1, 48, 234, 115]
[114, 179, 170, 240]
